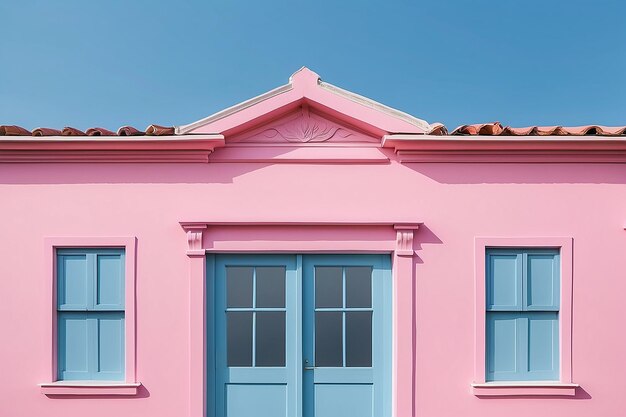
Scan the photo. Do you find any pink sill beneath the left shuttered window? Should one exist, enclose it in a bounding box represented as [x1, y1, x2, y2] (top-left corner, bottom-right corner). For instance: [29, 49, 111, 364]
[39, 381, 141, 395]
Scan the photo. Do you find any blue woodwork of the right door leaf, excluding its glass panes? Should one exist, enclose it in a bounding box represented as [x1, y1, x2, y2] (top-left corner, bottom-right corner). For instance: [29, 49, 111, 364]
[303, 255, 391, 417]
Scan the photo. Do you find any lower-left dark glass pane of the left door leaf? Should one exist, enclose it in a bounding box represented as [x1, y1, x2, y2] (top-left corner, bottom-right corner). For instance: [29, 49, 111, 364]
[226, 311, 252, 366]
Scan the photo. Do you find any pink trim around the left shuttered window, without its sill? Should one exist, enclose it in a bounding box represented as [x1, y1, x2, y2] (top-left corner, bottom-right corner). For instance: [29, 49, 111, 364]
[41, 236, 137, 395]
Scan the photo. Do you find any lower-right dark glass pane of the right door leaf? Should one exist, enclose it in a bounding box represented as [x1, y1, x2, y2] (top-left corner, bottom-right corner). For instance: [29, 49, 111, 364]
[346, 311, 372, 366]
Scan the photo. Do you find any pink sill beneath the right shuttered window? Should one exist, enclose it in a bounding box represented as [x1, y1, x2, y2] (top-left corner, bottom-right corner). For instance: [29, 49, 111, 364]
[472, 381, 579, 397]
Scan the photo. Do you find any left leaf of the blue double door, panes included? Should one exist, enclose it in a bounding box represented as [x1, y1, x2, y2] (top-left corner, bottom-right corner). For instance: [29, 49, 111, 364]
[209, 255, 301, 417]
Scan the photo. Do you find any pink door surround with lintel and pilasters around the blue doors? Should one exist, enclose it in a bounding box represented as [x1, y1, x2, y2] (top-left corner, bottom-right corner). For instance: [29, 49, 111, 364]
[181, 221, 420, 416]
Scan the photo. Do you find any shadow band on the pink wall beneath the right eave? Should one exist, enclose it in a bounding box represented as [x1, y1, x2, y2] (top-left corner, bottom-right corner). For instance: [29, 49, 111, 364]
[403, 163, 626, 184]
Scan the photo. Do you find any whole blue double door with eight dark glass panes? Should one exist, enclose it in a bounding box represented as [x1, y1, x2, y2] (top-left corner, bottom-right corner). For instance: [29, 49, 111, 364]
[207, 255, 392, 417]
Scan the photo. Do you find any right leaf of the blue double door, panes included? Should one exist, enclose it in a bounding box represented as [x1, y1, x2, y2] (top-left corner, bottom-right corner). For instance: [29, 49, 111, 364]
[303, 255, 391, 417]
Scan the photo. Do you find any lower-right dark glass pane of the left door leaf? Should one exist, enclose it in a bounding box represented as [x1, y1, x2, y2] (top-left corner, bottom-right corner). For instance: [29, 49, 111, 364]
[255, 311, 285, 366]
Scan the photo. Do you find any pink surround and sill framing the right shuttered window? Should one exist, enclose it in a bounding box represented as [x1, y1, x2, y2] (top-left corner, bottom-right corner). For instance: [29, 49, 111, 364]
[472, 237, 578, 396]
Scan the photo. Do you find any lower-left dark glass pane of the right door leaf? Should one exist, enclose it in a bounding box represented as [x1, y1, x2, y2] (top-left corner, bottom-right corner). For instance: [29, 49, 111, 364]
[315, 311, 343, 366]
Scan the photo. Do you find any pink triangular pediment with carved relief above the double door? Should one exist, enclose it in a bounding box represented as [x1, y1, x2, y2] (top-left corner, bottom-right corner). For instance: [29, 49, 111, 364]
[177, 68, 431, 144]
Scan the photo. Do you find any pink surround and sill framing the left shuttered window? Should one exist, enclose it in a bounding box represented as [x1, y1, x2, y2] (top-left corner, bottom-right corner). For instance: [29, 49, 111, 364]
[39, 236, 141, 396]
